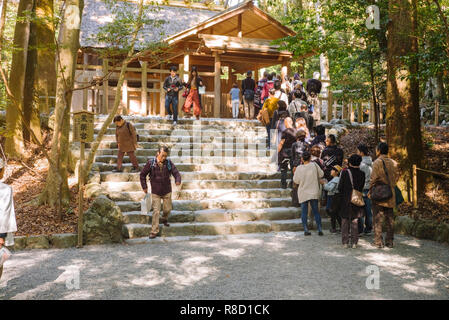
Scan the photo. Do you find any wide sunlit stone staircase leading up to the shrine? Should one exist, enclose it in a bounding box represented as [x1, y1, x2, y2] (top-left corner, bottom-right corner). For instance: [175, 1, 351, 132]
[87, 117, 328, 242]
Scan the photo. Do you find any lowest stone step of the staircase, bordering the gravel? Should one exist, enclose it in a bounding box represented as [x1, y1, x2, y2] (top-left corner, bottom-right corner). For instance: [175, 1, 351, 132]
[123, 219, 330, 239]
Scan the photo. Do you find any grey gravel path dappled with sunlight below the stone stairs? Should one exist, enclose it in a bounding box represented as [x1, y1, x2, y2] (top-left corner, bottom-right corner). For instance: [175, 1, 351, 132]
[0, 232, 449, 300]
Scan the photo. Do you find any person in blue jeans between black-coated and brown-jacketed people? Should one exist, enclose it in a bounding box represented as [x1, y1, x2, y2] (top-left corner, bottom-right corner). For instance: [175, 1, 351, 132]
[357, 144, 373, 235]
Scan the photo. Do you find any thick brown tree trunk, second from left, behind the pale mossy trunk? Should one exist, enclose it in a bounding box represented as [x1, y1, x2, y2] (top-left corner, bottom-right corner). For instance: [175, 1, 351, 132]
[35, 0, 56, 114]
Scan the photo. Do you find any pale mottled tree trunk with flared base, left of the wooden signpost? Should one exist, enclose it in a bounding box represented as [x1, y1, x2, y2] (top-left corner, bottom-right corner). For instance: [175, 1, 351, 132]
[39, 0, 84, 206]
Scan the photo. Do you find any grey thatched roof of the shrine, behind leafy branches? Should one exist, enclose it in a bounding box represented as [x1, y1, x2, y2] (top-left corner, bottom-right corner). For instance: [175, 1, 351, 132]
[80, 0, 217, 50]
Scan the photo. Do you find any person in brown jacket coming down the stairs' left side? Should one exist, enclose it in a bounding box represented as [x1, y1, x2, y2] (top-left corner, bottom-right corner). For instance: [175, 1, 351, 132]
[112, 115, 140, 172]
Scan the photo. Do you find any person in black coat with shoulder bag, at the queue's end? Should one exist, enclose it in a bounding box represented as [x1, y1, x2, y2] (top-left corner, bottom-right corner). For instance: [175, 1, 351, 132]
[338, 154, 365, 248]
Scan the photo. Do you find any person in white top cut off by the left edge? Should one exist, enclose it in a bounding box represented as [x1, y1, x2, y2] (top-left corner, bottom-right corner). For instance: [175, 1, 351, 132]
[0, 158, 17, 278]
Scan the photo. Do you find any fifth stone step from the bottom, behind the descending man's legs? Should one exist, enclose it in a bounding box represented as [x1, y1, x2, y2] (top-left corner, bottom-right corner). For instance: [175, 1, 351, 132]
[100, 171, 292, 182]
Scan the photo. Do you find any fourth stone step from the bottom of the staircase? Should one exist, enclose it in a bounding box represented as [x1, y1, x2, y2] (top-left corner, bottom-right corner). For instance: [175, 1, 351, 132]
[101, 179, 281, 192]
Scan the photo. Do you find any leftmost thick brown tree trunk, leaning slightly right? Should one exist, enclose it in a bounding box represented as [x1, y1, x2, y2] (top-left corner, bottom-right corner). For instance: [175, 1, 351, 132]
[5, 0, 34, 158]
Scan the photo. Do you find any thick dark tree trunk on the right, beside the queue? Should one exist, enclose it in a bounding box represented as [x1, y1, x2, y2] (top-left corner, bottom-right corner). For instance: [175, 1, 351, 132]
[386, 0, 423, 191]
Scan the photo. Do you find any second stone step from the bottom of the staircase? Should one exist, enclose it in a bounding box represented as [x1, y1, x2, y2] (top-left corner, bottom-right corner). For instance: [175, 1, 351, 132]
[123, 207, 301, 224]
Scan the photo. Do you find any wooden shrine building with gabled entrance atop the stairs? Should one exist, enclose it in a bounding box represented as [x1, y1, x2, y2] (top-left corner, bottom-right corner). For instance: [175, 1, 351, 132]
[72, 0, 295, 118]
